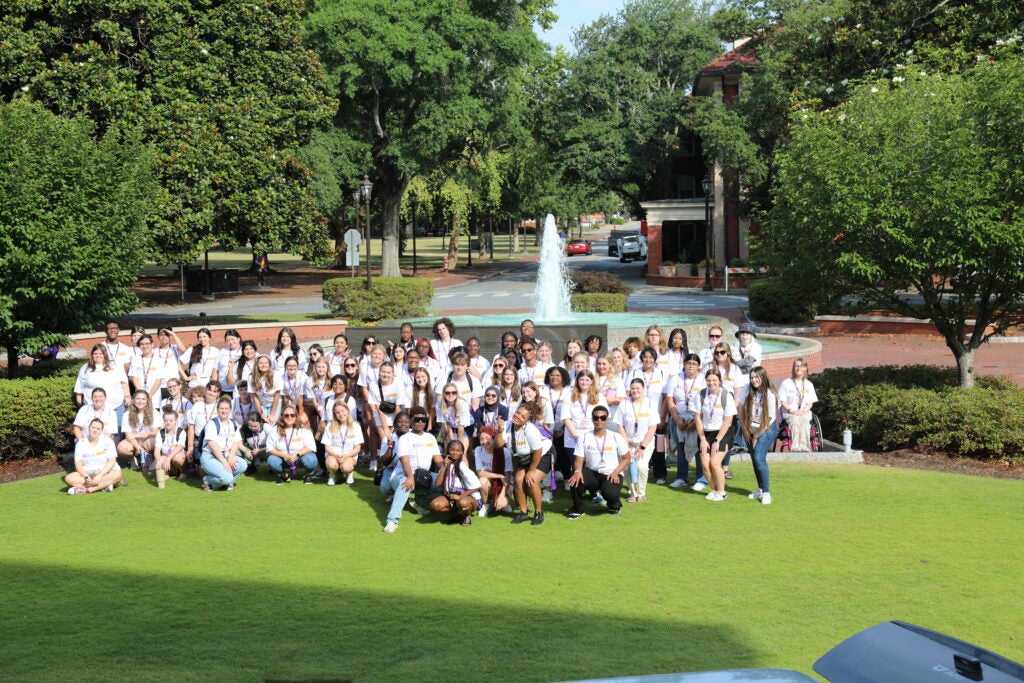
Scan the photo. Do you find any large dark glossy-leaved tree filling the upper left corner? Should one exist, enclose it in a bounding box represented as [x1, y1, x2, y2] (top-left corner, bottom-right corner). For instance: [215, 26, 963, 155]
[0, 0, 332, 262]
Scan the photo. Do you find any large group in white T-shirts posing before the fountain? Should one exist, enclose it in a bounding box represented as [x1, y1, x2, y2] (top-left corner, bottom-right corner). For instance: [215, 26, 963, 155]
[67, 317, 817, 532]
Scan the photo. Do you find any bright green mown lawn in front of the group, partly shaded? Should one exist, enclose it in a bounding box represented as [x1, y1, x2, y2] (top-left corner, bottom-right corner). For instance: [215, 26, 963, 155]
[0, 464, 1024, 681]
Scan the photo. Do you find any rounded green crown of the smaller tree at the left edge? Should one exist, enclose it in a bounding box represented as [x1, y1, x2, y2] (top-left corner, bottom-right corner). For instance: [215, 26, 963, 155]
[0, 99, 159, 378]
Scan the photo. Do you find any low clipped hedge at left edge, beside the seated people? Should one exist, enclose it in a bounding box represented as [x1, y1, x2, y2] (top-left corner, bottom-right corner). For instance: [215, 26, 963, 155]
[0, 374, 76, 463]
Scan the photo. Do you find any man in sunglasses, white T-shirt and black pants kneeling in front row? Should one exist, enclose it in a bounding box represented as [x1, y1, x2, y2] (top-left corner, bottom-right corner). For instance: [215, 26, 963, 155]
[565, 405, 630, 520]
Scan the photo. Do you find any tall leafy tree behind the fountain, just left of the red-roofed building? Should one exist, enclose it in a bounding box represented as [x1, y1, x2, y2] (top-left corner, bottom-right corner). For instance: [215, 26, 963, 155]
[544, 0, 721, 209]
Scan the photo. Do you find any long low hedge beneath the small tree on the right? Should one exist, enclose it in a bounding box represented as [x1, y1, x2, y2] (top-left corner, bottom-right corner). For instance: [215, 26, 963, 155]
[812, 366, 1024, 462]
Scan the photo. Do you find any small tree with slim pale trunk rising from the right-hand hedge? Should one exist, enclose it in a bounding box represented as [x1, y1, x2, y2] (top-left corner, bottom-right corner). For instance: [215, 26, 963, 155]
[765, 53, 1024, 387]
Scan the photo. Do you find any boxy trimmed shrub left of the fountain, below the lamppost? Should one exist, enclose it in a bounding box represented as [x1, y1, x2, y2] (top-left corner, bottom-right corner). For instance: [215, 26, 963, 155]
[323, 278, 434, 323]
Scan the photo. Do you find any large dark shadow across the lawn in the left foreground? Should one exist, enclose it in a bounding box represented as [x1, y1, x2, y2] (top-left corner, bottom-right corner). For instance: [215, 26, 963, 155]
[0, 561, 758, 681]
